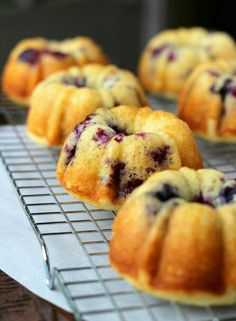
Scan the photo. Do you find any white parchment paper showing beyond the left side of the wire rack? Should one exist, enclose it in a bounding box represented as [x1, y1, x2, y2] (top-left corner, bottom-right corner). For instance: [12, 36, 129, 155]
[0, 160, 70, 311]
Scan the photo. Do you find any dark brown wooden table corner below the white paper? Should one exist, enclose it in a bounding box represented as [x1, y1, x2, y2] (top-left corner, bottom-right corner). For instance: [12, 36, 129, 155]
[0, 270, 75, 321]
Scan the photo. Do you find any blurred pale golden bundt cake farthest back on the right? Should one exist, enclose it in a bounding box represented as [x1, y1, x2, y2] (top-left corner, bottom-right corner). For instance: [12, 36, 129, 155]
[138, 28, 236, 97]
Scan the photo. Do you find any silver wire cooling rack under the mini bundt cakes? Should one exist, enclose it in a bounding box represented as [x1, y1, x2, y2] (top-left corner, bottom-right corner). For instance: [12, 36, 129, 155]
[0, 97, 236, 321]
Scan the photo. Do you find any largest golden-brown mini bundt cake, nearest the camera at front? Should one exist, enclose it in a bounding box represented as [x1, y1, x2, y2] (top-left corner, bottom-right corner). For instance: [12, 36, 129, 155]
[110, 167, 236, 305]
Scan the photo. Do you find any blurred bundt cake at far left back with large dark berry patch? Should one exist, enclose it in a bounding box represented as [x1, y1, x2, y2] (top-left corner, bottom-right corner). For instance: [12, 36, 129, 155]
[2, 37, 107, 105]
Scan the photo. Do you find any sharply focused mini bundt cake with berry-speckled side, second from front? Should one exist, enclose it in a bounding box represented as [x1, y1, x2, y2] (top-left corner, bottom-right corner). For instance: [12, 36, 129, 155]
[57, 106, 202, 210]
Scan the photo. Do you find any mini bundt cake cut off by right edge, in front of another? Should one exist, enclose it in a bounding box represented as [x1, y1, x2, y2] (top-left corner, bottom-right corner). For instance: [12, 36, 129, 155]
[178, 60, 236, 142]
